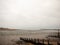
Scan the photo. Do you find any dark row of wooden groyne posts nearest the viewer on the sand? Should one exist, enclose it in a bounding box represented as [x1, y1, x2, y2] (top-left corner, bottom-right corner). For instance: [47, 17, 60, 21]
[20, 37, 53, 45]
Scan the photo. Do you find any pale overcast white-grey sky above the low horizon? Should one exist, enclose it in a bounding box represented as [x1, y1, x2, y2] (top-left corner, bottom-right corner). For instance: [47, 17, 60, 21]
[0, 0, 60, 29]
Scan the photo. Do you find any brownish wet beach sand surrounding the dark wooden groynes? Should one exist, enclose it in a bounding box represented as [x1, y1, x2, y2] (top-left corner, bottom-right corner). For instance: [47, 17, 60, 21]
[0, 30, 58, 45]
